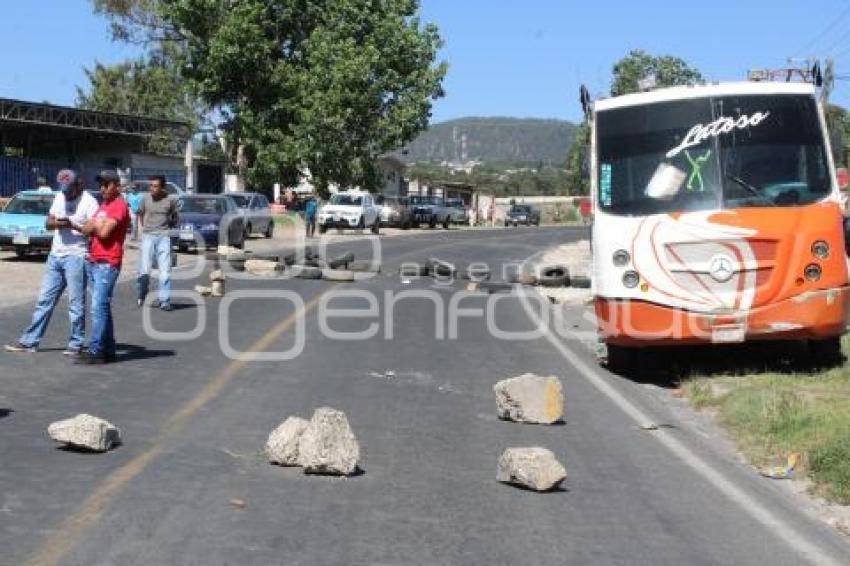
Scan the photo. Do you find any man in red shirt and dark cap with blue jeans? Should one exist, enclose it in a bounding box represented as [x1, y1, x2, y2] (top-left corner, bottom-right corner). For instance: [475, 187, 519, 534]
[76, 171, 130, 364]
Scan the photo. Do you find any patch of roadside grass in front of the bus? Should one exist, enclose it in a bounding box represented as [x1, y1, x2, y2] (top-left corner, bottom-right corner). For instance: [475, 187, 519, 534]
[682, 336, 850, 505]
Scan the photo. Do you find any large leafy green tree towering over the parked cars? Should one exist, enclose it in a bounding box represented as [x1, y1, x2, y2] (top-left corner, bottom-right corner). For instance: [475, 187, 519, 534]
[95, 0, 446, 193]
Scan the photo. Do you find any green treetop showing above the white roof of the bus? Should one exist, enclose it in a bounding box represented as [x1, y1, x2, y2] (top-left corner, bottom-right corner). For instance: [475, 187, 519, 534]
[611, 49, 703, 96]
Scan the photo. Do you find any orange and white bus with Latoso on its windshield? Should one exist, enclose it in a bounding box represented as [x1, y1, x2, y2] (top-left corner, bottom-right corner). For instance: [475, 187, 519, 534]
[590, 82, 850, 369]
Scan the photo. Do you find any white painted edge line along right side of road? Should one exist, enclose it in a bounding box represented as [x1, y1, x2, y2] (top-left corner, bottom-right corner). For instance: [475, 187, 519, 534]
[519, 289, 842, 566]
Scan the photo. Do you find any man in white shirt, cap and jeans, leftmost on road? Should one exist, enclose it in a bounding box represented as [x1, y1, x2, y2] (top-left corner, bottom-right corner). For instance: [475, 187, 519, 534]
[6, 169, 98, 356]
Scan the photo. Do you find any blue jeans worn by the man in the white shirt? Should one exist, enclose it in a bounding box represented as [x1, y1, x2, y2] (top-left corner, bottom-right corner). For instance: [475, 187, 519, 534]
[18, 254, 86, 350]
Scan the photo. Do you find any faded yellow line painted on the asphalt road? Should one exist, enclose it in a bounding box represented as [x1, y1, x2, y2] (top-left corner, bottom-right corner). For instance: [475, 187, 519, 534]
[28, 293, 324, 566]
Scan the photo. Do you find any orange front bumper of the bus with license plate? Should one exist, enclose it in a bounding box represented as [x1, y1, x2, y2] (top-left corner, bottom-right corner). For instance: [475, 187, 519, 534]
[594, 286, 850, 346]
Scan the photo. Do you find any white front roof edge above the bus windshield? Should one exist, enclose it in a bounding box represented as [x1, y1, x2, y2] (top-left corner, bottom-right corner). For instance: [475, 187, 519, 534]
[593, 81, 815, 112]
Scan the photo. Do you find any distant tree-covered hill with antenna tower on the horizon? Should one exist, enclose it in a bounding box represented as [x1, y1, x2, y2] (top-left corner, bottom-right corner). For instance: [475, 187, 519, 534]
[401, 118, 575, 166]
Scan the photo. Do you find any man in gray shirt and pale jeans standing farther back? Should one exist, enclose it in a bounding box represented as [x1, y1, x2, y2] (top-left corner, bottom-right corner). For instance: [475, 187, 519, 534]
[136, 175, 177, 311]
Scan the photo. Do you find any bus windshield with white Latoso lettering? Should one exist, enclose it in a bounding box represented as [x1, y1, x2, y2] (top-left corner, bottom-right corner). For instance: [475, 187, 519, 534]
[596, 94, 831, 216]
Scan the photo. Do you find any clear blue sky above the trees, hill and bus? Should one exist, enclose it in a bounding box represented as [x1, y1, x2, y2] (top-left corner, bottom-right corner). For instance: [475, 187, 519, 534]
[0, 0, 850, 121]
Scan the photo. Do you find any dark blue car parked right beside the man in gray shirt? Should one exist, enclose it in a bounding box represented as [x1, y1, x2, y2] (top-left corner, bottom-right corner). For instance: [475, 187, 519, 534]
[171, 195, 247, 251]
